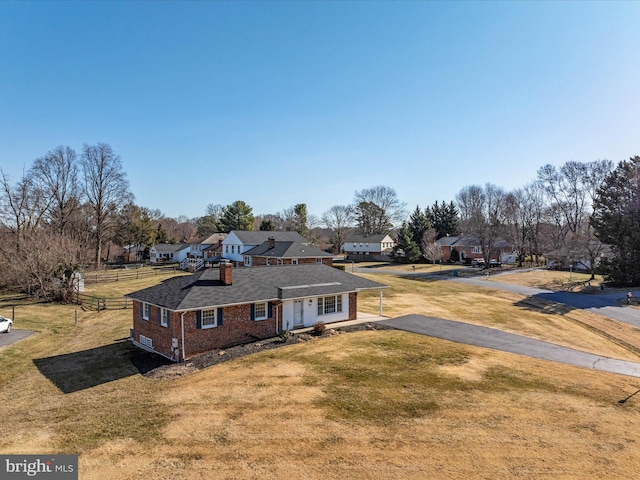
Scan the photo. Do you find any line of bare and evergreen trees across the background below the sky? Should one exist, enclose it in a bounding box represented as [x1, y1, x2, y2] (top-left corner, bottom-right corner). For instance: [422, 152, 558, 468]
[0, 143, 640, 297]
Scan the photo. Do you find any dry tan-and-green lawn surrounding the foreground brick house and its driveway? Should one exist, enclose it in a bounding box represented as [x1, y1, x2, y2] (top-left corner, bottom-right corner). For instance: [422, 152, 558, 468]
[0, 266, 640, 480]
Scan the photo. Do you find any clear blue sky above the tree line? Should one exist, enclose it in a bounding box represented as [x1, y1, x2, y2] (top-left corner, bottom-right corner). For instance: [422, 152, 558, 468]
[0, 1, 640, 221]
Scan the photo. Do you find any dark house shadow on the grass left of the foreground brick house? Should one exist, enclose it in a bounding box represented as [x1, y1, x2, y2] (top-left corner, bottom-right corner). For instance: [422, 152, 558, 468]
[33, 340, 171, 393]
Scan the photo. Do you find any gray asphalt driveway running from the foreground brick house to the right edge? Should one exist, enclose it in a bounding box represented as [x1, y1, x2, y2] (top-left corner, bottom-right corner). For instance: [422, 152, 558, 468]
[379, 315, 640, 377]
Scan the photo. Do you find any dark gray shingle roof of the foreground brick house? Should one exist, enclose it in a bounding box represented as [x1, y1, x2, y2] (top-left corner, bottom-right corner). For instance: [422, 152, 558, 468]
[126, 264, 386, 311]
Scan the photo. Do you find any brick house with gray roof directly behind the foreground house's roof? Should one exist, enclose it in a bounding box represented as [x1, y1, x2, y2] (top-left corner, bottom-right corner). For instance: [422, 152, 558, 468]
[243, 235, 333, 267]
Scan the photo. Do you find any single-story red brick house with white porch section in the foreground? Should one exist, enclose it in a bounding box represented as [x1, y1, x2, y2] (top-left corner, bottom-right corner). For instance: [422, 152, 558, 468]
[126, 263, 386, 361]
